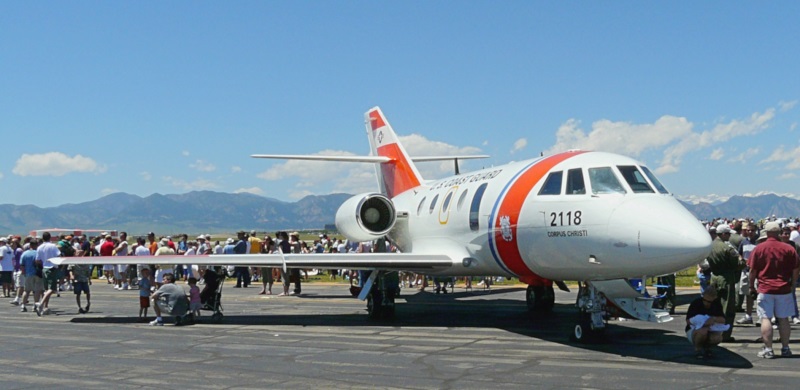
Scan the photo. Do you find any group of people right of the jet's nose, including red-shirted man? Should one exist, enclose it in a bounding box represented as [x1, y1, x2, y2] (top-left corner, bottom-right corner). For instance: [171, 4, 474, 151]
[686, 216, 800, 359]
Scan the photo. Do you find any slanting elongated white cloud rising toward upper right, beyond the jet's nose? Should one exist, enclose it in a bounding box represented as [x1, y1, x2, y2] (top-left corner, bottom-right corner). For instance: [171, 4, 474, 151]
[656, 108, 775, 173]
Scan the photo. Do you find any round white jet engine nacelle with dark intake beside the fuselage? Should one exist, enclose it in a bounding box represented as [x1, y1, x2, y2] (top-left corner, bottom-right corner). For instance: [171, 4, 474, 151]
[336, 193, 396, 242]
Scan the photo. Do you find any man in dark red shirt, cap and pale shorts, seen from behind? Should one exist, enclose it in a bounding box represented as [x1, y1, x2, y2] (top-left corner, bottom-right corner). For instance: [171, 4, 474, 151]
[749, 222, 800, 359]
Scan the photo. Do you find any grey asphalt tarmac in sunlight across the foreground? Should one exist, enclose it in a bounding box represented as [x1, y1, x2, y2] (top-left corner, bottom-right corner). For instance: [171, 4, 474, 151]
[0, 282, 800, 389]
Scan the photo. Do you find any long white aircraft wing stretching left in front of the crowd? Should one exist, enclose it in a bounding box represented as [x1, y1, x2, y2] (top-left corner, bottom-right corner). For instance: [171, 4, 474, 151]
[50, 253, 453, 271]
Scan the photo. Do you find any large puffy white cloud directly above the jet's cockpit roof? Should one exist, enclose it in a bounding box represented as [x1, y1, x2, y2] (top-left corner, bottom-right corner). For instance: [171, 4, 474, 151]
[545, 115, 692, 156]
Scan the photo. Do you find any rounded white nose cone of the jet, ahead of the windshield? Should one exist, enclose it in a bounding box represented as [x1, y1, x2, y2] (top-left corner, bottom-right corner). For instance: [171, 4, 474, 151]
[610, 197, 711, 275]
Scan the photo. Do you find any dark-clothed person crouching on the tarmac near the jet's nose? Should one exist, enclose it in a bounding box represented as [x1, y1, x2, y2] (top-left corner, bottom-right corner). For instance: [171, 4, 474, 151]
[686, 286, 725, 359]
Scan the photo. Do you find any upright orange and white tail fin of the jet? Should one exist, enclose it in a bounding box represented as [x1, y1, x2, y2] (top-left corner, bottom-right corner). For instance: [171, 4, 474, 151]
[364, 107, 422, 198]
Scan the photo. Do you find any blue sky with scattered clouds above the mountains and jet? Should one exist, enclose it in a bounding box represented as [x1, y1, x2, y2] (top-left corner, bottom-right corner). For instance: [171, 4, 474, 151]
[0, 1, 800, 207]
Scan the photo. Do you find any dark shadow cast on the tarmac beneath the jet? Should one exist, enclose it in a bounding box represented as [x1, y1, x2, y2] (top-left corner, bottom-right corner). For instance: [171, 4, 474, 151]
[70, 288, 759, 369]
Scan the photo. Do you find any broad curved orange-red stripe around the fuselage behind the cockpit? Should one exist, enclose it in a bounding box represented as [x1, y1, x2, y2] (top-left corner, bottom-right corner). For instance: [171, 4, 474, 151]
[493, 152, 585, 275]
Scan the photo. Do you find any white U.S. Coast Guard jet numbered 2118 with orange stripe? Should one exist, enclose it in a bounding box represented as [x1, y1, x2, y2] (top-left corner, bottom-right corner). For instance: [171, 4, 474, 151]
[54, 107, 711, 340]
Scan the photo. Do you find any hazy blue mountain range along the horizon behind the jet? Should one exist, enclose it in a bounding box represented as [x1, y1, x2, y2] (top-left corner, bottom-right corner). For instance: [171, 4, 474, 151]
[0, 191, 800, 235]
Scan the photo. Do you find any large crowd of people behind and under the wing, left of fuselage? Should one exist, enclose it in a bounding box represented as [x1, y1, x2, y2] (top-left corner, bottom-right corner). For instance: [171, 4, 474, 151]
[0, 230, 400, 325]
